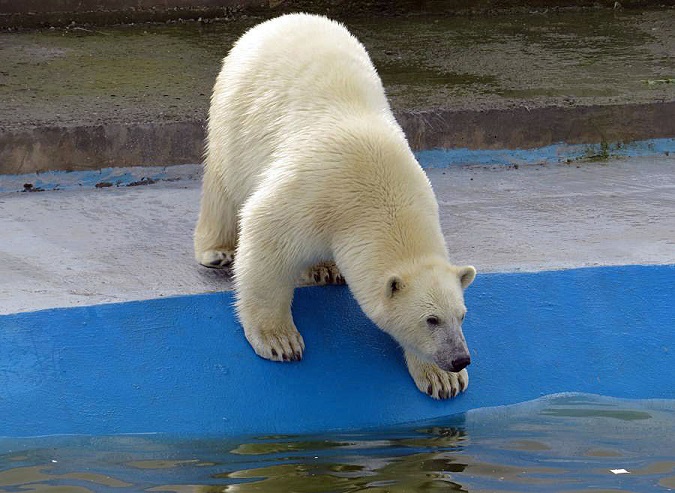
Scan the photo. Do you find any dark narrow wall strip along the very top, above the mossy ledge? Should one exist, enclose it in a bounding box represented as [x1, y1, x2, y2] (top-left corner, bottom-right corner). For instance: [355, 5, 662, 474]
[0, 0, 673, 28]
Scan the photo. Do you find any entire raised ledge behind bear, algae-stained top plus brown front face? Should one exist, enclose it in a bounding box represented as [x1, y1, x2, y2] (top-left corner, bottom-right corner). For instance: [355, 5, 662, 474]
[0, 8, 675, 173]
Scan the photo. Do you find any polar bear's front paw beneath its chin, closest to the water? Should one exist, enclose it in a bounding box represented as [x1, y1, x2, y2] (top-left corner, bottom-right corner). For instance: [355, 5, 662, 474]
[405, 352, 469, 399]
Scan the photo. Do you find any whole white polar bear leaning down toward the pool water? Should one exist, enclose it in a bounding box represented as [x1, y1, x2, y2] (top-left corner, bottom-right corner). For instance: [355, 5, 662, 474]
[194, 14, 476, 399]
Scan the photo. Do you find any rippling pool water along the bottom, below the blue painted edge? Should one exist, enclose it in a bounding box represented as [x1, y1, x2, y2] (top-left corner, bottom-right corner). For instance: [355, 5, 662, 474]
[0, 394, 675, 493]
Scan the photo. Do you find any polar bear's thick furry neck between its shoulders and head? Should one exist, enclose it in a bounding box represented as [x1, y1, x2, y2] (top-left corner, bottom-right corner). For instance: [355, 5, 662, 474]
[327, 114, 448, 316]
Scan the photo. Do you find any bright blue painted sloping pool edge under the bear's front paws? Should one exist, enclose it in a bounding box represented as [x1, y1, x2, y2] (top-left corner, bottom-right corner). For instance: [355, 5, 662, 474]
[0, 266, 675, 436]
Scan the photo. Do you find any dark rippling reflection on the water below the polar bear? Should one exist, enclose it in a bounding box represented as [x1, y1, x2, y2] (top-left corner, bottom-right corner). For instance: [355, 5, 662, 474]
[222, 427, 468, 493]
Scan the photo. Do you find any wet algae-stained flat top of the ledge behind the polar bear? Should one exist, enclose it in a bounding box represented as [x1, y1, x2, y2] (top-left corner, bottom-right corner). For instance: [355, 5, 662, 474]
[0, 9, 675, 129]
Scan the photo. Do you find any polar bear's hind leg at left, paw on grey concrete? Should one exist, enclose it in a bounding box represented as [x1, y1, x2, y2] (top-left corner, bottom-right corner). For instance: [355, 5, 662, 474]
[194, 166, 238, 269]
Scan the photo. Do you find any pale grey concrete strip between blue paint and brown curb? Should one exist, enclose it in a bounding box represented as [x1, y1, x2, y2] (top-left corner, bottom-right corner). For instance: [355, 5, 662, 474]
[0, 154, 675, 314]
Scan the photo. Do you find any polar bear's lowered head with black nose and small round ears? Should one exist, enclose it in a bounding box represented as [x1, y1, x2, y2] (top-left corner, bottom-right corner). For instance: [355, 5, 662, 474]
[377, 261, 476, 372]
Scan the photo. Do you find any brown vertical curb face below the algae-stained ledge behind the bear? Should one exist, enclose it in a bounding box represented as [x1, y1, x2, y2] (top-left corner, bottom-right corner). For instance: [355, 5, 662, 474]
[0, 101, 675, 175]
